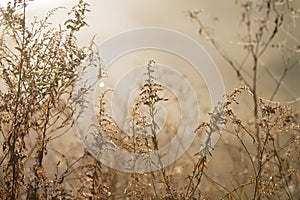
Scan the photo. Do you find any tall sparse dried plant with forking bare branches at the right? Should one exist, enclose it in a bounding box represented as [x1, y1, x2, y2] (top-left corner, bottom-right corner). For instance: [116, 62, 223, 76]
[187, 0, 299, 199]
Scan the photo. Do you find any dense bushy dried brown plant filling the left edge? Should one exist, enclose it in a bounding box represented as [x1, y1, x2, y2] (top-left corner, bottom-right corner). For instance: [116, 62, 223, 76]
[0, 0, 93, 199]
